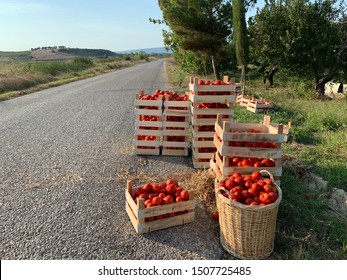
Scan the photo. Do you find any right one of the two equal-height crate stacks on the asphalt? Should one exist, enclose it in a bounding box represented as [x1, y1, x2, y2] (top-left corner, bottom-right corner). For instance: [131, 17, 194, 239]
[162, 98, 191, 156]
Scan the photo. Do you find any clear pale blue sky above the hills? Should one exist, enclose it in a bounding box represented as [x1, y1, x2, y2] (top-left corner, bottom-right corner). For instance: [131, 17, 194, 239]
[0, 0, 264, 51]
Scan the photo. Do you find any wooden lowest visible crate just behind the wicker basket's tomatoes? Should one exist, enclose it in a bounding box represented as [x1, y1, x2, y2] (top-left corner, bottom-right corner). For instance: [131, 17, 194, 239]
[215, 152, 282, 176]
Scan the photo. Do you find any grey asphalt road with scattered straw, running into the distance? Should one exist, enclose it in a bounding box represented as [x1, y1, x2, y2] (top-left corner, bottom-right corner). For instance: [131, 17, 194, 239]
[0, 60, 225, 260]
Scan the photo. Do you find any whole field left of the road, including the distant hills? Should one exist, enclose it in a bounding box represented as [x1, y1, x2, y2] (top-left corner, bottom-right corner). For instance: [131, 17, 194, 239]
[0, 49, 154, 101]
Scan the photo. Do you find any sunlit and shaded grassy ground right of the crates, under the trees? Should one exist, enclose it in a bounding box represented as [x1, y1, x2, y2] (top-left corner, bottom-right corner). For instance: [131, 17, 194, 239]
[167, 57, 347, 260]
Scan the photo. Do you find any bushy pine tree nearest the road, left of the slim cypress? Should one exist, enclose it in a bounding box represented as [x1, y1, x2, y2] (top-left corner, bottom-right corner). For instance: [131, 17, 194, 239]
[156, 0, 231, 79]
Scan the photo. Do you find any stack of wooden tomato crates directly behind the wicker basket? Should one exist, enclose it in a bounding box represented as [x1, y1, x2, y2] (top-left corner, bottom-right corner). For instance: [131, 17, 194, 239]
[210, 116, 284, 184]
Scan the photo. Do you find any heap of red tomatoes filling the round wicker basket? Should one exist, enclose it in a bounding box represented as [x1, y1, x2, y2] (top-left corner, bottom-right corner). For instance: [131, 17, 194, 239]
[218, 171, 278, 206]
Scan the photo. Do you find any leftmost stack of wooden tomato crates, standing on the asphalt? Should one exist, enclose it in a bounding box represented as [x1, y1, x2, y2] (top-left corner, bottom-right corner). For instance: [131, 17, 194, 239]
[133, 90, 163, 155]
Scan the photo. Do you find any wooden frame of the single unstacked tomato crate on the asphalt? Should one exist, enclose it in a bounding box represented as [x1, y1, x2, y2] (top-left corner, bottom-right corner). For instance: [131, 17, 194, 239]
[125, 178, 196, 234]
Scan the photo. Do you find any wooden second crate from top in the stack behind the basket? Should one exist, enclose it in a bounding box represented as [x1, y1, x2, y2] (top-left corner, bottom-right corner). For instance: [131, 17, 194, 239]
[213, 135, 282, 158]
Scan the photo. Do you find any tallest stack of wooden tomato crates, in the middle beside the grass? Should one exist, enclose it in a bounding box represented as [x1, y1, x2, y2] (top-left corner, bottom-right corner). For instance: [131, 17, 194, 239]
[189, 76, 238, 168]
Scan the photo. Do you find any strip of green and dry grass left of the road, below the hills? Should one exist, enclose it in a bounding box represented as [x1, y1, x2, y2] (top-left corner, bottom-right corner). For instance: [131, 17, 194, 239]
[0, 55, 153, 101]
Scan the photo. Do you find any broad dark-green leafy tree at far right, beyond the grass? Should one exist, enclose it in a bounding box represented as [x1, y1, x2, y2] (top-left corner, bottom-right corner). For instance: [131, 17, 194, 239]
[249, 0, 344, 91]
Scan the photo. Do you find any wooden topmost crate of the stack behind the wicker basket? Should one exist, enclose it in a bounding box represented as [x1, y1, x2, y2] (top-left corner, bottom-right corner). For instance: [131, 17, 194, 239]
[215, 116, 284, 143]
